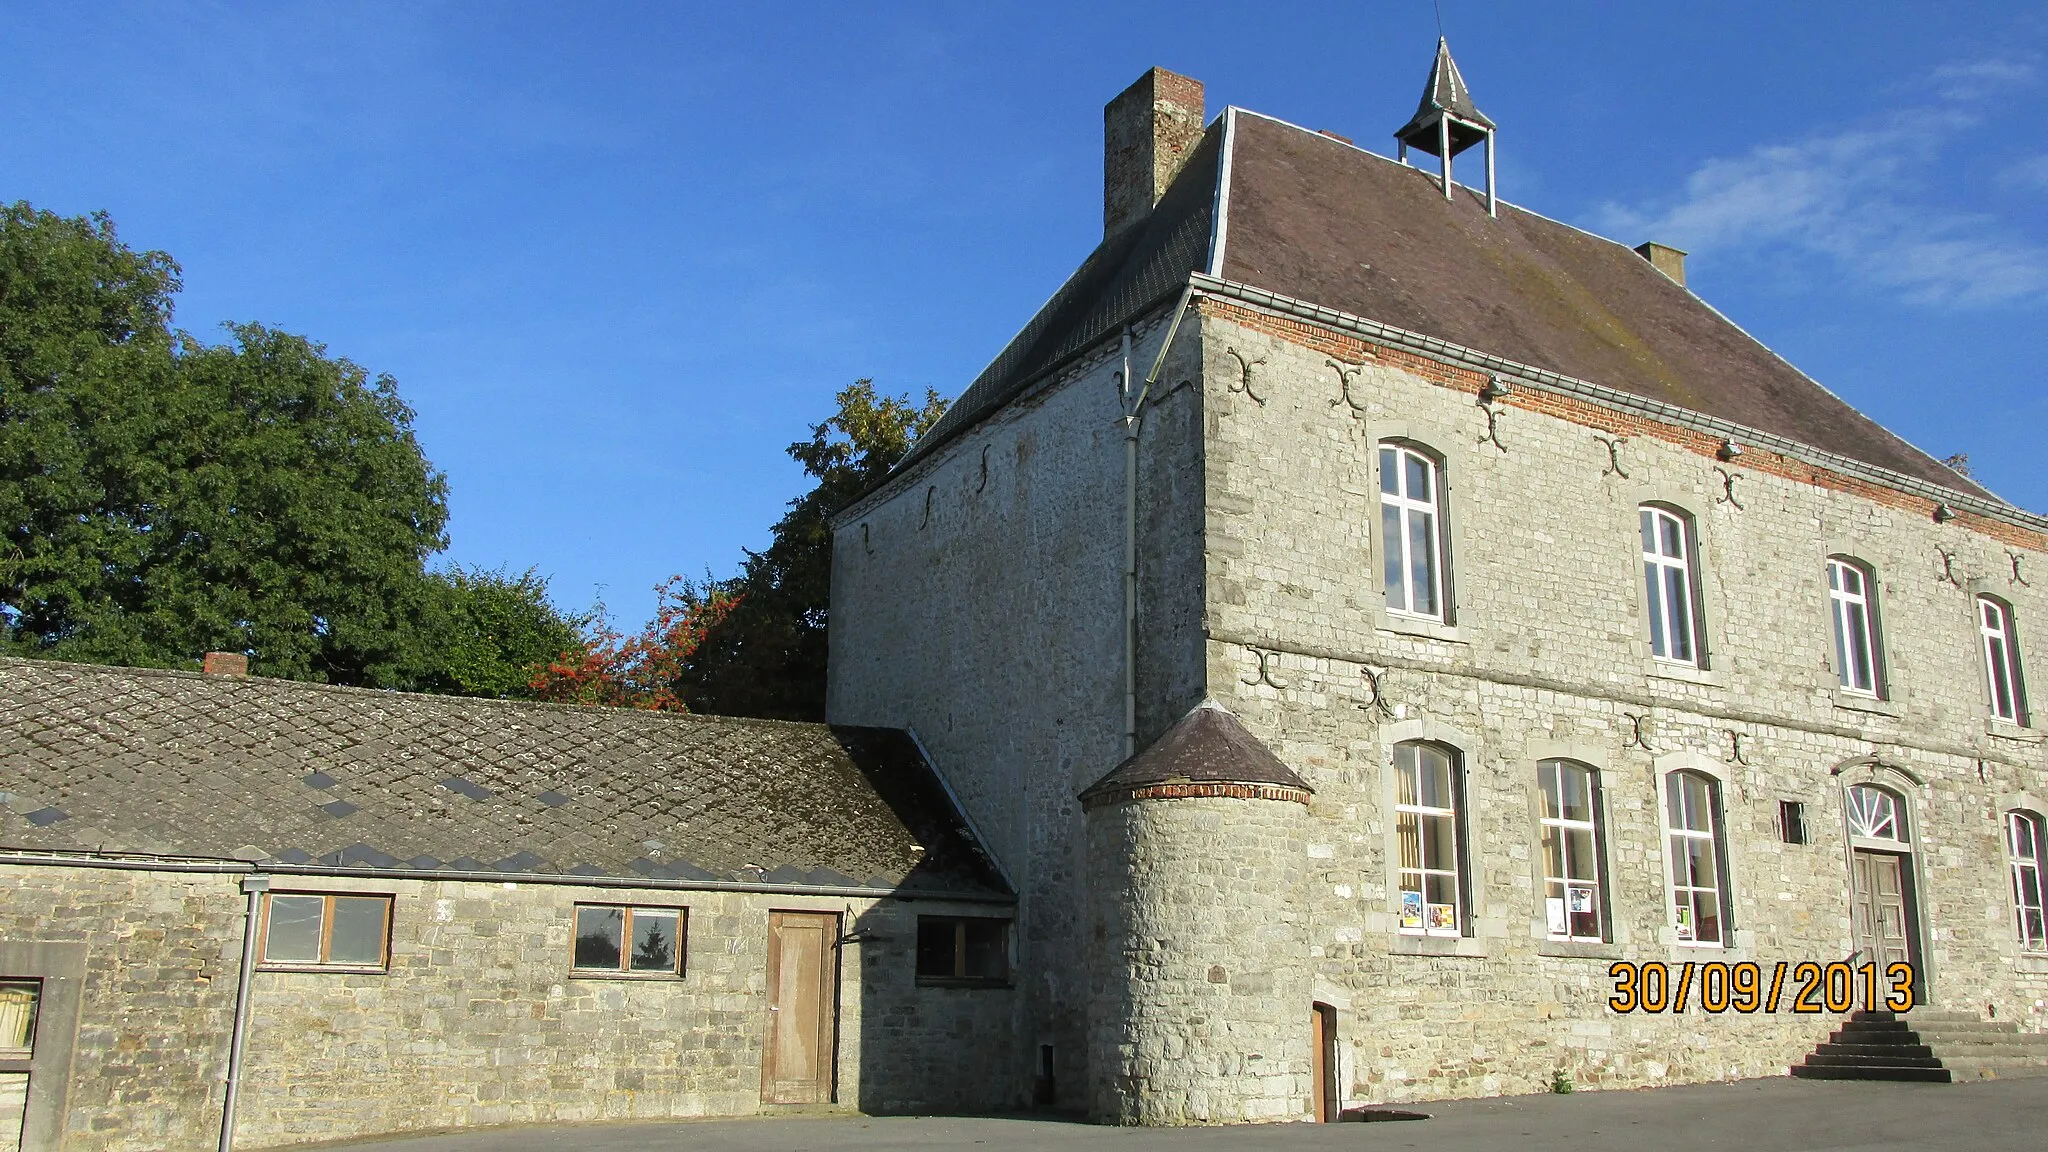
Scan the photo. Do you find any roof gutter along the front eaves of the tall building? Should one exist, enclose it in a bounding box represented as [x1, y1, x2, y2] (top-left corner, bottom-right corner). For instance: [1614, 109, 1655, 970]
[1188, 273, 2048, 533]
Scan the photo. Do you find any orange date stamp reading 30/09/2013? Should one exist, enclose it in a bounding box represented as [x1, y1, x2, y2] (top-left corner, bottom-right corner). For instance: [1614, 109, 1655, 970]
[1608, 959, 1919, 1015]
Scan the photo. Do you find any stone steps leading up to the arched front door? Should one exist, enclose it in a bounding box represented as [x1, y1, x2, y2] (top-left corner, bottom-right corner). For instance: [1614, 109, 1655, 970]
[1792, 1009, 2048, 1084]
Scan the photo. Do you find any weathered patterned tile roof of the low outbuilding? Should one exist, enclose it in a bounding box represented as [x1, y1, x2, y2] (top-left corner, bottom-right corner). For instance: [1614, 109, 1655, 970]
[0, 660, 1006, 894]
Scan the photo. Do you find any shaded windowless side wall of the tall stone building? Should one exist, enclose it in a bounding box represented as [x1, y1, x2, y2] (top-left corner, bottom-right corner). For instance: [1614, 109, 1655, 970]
[827, 316, 1204, 1109]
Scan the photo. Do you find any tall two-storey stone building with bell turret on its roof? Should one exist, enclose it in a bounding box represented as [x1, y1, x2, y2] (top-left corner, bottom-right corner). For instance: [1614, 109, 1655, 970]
[829, 45, 2048, 1123]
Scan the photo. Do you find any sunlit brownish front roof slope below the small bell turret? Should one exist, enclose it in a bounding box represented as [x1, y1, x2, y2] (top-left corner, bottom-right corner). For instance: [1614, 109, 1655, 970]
[1223, 113, 1989, 498]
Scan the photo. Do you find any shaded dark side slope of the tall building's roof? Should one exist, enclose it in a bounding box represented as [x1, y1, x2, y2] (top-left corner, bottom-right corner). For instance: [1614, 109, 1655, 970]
[897, 121, 1223, 469]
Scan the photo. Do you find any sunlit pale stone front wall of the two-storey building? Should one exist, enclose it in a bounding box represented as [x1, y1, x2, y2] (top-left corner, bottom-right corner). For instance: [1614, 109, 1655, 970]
[1196, 305, 2048, 1105]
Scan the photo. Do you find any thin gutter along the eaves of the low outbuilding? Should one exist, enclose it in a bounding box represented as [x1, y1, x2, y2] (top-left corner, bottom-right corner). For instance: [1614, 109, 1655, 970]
[0, 851, 1016, 904]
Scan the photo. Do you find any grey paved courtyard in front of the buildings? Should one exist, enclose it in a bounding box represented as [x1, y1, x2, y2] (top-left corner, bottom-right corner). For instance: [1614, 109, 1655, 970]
[307, 1078, 2048, 1152]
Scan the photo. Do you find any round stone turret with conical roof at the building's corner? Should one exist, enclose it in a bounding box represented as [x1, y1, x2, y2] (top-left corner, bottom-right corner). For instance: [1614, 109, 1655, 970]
[1081, 701, 1311, 1123]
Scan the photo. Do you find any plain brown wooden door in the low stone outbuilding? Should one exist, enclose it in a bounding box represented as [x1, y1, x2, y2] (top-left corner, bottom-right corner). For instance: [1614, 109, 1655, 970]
[762, 912, 840, 1105]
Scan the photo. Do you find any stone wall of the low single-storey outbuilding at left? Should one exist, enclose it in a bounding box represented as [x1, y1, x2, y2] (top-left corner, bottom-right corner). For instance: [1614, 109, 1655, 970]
[0, 867, 1024, 1152]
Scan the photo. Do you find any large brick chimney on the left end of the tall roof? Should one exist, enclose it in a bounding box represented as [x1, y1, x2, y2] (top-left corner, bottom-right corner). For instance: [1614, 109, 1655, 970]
[1102, 68, 1204, 240]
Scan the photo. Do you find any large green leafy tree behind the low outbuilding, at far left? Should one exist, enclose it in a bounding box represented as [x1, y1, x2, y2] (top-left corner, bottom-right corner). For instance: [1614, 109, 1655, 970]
[0, 203, 446, 685]
